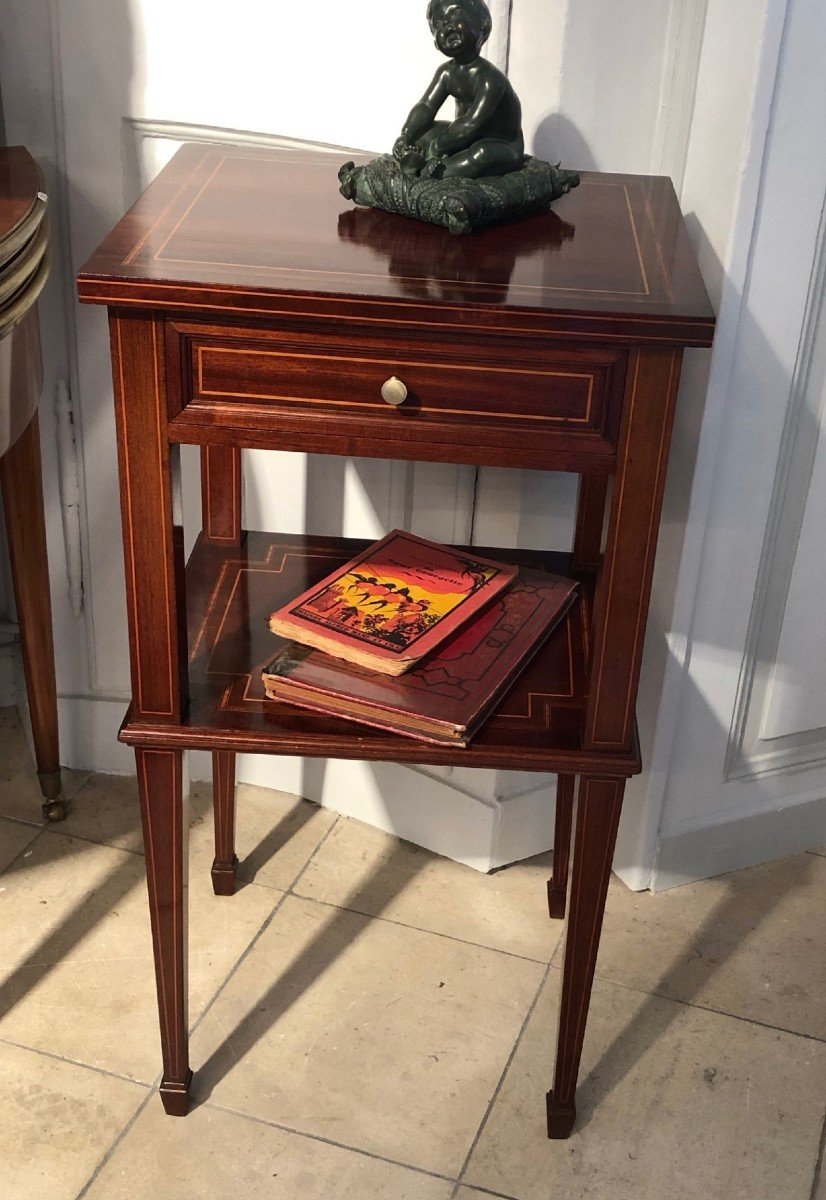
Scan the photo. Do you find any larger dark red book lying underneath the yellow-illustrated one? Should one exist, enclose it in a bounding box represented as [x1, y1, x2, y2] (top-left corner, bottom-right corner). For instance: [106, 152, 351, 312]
[262, 570, 576, 745]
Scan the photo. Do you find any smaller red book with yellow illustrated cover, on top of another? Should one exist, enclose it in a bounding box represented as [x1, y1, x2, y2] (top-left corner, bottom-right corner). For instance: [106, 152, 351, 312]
[269, 529, 517, 676]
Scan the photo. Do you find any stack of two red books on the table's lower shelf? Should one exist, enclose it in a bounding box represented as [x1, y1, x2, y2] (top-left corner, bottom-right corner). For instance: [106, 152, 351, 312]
[263, 529, 576, 745]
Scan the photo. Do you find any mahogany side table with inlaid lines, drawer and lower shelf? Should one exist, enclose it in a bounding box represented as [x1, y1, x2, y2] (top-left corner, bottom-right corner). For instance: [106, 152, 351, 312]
[79, 145, 714, 1138]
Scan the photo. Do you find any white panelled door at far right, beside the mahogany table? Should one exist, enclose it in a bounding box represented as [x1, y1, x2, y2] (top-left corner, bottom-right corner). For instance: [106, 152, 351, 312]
[652, 0, 826, 887]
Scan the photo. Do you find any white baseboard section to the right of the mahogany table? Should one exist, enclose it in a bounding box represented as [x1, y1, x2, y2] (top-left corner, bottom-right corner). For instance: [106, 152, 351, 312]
[651, 797, 826, 892]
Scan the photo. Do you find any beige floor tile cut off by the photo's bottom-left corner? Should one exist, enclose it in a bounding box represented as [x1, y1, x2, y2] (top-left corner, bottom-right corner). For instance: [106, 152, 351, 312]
[0, 1043, 146, 1200]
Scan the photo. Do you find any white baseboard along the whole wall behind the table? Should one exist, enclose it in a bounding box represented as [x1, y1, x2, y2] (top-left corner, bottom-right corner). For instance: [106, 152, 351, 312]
[48, 691, 826, 892]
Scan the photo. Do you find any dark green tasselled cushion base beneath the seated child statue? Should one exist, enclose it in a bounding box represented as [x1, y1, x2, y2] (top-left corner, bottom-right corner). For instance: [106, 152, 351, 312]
[339, 155, 580, 234]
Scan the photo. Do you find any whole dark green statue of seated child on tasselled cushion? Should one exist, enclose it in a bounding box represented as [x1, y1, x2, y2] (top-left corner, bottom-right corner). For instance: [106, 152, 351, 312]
[339, 0, 580, 233]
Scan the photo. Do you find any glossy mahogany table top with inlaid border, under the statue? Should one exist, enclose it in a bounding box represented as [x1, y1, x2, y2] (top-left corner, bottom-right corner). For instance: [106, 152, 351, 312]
[78, 144, 714, 346]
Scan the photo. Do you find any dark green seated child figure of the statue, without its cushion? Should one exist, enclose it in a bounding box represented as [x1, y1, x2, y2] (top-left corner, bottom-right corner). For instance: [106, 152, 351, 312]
[393, 0, 525, 179]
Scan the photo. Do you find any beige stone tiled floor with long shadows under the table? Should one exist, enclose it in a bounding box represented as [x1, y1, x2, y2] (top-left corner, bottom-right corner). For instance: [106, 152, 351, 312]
[0, 712, 826, 1200]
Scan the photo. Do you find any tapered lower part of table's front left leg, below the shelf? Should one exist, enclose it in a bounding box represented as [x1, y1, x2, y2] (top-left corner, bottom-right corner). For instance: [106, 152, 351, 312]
[134, 750, 192, 1117]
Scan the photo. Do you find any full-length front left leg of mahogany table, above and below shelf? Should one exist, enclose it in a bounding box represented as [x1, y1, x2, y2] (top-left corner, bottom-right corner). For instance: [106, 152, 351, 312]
[109, 312, 190, 1116]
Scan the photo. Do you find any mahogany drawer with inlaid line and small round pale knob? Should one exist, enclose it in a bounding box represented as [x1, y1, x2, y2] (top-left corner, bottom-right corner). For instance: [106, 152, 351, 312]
[169, 323, 626, 468]
